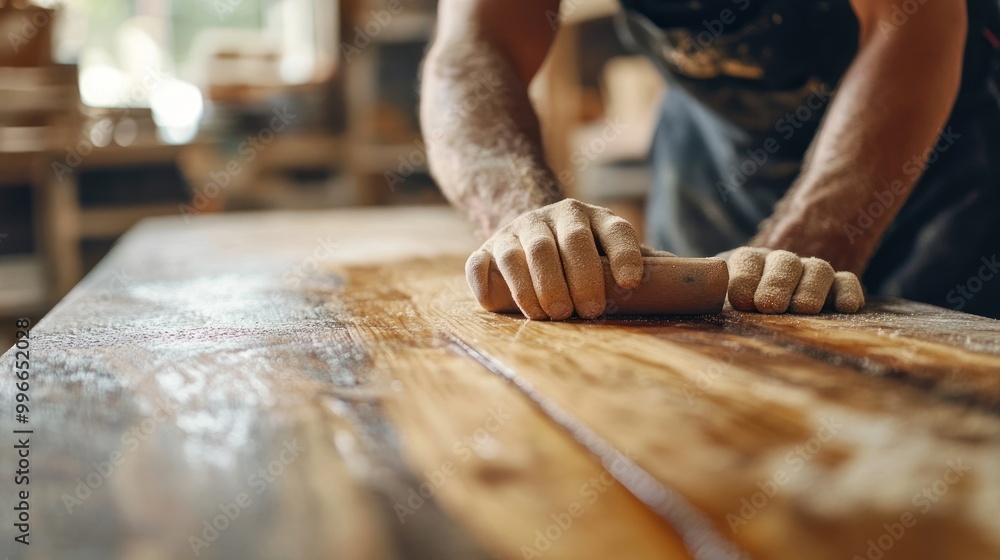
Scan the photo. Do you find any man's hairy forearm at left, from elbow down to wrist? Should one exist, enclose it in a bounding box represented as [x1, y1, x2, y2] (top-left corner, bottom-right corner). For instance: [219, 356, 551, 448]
[420, 39, 562, 237]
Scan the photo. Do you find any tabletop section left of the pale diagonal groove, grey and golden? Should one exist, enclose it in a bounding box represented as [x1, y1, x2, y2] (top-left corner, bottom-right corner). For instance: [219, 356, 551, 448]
[0, 210, 683, 559]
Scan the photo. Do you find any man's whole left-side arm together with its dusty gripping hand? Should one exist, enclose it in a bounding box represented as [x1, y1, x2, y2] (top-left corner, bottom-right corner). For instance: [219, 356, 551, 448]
[420, 0, 656, 320]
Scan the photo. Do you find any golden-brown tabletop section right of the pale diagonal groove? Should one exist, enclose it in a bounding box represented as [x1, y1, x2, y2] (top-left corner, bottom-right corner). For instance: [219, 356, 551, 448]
[370, 255, 1000, 559]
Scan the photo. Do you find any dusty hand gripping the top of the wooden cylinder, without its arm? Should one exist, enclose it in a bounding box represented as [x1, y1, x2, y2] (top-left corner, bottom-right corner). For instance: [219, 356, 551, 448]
[465, 199, 648, 321]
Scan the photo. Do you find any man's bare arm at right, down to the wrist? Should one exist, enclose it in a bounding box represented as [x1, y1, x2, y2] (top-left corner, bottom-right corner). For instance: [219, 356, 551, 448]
[751, 0, 967, 274]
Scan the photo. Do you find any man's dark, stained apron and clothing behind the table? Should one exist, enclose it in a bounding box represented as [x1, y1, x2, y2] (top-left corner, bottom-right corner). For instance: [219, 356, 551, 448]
[618, 0, 1000, 317]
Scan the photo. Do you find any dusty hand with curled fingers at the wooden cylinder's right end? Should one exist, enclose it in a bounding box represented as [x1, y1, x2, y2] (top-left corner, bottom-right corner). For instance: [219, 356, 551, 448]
[719, 247, 865, 314]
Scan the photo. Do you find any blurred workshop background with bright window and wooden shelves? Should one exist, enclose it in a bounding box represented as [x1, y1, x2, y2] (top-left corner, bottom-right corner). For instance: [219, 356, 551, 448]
[0, 0, 664, 347]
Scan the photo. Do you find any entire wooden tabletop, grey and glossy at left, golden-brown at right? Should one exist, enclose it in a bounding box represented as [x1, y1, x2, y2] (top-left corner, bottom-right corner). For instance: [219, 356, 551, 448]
[0, 209, 1000, 560]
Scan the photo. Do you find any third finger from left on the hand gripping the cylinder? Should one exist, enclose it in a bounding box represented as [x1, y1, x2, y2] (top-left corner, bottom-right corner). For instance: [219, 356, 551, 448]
[517, 221, 573, 321]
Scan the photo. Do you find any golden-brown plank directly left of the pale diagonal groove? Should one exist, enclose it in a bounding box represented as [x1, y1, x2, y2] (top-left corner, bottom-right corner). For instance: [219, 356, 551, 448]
[336, 261, 687, 559]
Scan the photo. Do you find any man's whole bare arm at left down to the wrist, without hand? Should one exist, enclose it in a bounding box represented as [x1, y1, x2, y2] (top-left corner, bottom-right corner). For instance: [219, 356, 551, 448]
[420, 0, 562, 237]
